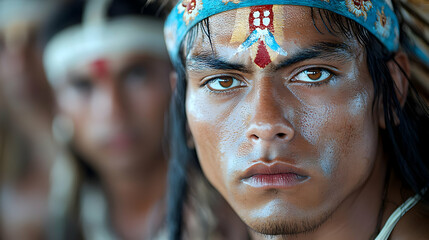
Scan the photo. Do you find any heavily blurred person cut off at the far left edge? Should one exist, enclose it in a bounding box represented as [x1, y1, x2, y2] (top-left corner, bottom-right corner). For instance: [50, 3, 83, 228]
[0, 0, 56, 239]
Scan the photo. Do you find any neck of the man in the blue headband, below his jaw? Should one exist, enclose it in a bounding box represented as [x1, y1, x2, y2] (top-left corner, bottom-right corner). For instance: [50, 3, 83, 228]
[250, 144, 387, 240]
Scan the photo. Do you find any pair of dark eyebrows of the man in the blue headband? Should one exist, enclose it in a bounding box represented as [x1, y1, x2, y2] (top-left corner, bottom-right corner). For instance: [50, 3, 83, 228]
[186, 42, 355, 73]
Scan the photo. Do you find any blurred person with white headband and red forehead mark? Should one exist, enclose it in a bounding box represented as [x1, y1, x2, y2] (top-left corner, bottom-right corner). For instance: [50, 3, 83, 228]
[44, 0, 171, 240]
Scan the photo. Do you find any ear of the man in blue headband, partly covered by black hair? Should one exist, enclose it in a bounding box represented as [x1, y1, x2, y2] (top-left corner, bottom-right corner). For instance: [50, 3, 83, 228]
[379, 52, 410, 129]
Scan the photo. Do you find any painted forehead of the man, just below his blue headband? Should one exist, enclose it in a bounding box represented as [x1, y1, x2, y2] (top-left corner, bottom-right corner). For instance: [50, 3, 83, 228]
[188, 5, 359, 57]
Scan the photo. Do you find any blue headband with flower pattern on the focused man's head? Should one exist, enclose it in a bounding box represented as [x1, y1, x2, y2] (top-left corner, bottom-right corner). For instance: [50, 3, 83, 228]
[165, 0, 399, 61]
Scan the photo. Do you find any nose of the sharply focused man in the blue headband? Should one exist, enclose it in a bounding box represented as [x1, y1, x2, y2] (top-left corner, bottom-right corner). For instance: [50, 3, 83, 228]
[247, 83, 295, 142]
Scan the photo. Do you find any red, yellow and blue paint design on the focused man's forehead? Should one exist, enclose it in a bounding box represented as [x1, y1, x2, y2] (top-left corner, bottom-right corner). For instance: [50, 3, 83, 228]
[230, 5, 287, 68]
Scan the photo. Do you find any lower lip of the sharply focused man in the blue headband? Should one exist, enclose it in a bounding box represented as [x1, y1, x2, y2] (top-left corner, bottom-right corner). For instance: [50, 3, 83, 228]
[242, 173, 308, 188]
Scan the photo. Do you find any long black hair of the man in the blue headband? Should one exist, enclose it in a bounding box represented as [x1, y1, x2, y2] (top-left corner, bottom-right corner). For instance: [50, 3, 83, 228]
[168, 3, 429, 239]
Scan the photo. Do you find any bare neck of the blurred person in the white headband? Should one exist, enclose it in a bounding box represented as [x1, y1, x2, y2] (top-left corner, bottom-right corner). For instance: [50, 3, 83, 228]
[101, 153, 167, 239]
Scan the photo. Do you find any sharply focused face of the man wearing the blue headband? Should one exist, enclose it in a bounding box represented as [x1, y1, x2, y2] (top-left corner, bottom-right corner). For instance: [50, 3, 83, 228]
[186, 6, 380, 234]
